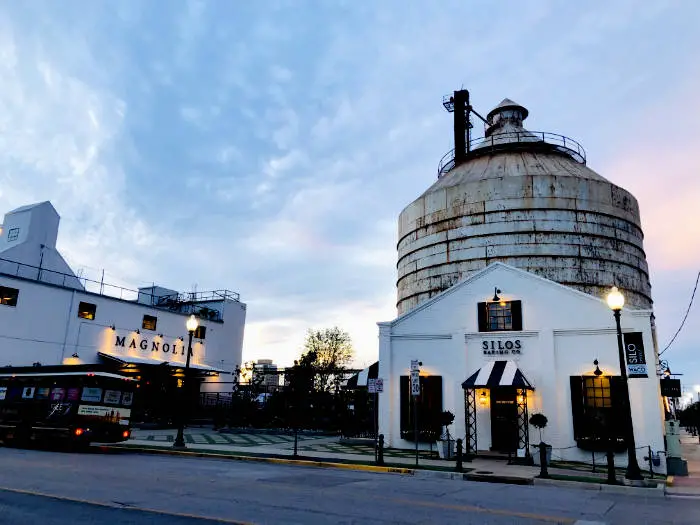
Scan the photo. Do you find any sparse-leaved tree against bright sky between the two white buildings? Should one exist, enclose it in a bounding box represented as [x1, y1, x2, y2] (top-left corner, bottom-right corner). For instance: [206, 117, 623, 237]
[302, 326, 353, 392]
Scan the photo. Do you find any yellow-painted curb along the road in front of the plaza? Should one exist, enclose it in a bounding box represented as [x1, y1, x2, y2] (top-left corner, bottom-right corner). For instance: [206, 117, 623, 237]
[108, 446, 415, 476]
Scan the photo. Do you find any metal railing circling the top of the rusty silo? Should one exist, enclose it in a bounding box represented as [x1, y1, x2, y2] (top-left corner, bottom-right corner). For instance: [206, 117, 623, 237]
[438, 131, 586, 178]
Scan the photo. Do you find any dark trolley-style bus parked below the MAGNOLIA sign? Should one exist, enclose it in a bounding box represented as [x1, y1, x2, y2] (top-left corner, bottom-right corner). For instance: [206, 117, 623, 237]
[0, 366, 137, 446]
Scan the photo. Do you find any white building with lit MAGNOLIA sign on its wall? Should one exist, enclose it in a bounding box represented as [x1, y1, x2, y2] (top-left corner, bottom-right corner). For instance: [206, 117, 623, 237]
[0, 202, 246, 404]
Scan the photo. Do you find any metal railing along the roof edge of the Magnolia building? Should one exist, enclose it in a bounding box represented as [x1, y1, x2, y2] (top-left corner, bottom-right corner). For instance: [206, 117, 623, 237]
[0, 257, 240, 314]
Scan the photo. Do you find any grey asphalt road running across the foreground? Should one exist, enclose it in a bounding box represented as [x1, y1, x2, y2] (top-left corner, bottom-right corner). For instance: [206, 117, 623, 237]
[0, 448, 700, 525]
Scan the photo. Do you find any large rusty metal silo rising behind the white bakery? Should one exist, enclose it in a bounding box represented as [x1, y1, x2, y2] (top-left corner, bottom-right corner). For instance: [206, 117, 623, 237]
[397, 91, 652, 315]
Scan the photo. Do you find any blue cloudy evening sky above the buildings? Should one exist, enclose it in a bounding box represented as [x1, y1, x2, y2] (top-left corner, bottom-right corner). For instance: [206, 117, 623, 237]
[0, 0, 700, 385]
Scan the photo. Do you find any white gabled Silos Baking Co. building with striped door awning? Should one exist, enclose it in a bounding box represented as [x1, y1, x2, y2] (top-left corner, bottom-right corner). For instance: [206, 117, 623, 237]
[379, 263, 664, 470]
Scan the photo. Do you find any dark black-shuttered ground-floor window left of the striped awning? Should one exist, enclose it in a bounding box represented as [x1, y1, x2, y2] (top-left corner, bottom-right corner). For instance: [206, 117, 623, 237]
[399, 376, 442, 442]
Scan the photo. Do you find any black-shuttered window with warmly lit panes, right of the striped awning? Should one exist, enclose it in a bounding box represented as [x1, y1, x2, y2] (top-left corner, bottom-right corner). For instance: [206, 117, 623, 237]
[571, 376, 629, 451]
